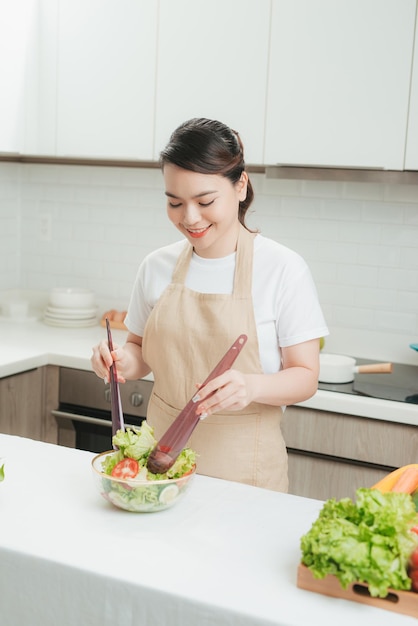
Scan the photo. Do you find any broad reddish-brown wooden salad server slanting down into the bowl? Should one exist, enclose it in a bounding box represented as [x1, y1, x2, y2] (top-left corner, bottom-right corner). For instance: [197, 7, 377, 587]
[147, 335, 247, 474]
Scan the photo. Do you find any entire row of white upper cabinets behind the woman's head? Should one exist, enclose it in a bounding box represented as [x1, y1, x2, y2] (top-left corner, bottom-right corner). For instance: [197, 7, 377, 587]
[5, 0, 418, 170]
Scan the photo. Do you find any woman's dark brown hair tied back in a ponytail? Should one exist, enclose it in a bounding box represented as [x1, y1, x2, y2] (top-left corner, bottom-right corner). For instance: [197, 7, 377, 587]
[160, 118, 254, 230]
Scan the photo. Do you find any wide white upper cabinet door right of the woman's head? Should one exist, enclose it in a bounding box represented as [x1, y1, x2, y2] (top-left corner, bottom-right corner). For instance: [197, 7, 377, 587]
[265, 0, 416, 170]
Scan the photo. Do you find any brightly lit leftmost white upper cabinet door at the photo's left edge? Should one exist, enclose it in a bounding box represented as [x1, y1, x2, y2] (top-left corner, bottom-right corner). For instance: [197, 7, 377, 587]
[0, 0, 58, 155]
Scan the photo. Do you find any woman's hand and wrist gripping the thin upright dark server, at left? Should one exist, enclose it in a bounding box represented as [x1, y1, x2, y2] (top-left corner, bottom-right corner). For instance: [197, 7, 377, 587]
[91, 333, 151, 383]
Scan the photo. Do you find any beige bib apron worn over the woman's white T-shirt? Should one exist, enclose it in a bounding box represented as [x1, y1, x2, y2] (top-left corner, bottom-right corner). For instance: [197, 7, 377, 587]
[143, 227, 288, 491]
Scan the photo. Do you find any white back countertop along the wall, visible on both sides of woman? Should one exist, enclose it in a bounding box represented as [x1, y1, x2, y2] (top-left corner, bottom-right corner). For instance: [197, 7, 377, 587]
[0, 318, 418, 426]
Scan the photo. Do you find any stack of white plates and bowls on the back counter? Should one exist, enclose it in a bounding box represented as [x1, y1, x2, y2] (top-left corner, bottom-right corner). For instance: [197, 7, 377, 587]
[43, 287, 97, 328]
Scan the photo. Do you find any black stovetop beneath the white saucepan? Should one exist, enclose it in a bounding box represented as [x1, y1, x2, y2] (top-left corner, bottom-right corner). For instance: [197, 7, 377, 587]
[318, 358, 418, 404]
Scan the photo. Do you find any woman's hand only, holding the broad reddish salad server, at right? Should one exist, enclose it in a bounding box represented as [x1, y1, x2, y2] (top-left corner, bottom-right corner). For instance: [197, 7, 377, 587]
[193, 370, 252, 419]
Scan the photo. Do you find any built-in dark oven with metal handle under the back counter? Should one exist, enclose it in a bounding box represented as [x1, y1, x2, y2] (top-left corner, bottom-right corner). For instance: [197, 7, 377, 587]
[52, 367, 153, 453]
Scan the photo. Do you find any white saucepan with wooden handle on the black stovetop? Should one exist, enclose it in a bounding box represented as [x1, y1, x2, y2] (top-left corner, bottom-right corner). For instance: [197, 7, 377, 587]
[319, 353, 392, 383]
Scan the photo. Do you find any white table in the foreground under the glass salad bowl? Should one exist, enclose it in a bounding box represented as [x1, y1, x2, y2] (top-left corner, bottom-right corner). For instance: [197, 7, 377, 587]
[0, 435, 417, 626]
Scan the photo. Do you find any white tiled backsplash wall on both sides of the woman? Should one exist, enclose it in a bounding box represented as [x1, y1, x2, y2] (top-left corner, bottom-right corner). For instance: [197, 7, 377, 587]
[0, 163, 418, 364]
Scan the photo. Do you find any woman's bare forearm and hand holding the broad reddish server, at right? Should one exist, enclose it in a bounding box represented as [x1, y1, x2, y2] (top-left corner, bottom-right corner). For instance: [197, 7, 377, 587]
[195, 339, 319, 415]
